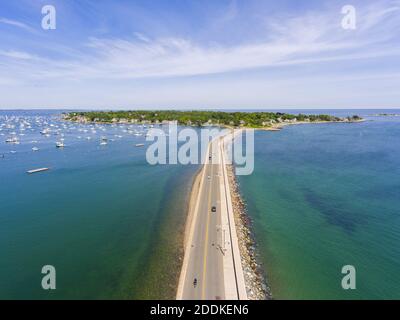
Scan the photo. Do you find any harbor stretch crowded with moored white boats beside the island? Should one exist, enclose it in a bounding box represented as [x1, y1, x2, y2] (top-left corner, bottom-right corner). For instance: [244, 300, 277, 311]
[0, 113, 160, 159]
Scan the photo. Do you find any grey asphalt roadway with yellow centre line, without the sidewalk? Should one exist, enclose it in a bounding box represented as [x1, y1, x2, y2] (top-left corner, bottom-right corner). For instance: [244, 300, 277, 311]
[182, 141, 225, 300]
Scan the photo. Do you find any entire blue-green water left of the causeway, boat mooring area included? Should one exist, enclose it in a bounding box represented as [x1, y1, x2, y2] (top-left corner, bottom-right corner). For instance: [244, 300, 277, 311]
[0, 111, 198, 299]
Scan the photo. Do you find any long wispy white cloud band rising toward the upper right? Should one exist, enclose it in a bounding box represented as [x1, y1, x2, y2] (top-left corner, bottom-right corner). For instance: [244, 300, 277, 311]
[0, 1, 399, 84]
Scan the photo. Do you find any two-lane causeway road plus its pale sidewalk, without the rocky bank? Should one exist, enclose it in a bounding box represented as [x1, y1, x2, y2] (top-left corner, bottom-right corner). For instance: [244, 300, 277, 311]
[177, 138, 247, 300]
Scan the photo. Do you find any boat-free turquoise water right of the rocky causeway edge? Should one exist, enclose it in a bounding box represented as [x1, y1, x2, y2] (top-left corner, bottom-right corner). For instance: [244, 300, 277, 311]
[239, 110, 400, 299]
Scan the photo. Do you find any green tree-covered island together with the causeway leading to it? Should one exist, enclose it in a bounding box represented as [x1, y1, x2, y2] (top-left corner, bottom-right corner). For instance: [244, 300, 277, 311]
[64, 111, 363, 300]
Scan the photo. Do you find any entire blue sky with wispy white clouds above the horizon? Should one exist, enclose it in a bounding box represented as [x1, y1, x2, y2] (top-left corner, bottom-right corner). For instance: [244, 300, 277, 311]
[0, 0, 400, 109]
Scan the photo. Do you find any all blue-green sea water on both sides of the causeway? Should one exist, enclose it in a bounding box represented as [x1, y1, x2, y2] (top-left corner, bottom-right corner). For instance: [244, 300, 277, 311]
[0, 110, 400, 299]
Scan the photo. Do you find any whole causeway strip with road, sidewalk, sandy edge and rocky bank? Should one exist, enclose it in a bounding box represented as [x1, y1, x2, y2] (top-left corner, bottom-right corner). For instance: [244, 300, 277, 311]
[177, 130, 271, 300]
